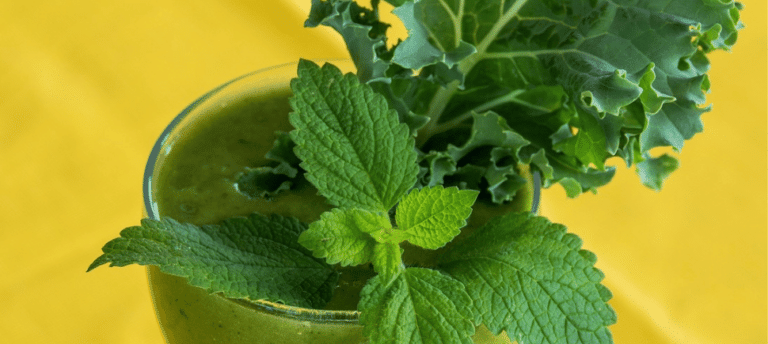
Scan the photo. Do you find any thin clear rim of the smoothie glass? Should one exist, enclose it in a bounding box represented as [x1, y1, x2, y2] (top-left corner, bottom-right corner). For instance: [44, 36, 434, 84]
[142, 59, 541, 323]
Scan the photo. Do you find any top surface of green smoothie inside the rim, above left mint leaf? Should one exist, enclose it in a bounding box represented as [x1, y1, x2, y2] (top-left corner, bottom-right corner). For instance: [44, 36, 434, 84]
[154, 89, 329, 224]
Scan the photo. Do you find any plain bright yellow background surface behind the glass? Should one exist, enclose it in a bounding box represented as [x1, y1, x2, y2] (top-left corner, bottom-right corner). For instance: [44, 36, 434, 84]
[0, 0, 768, 344]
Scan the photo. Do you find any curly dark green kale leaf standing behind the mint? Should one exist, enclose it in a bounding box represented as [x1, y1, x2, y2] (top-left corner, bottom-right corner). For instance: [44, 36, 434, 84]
[308, 0, 742, 199]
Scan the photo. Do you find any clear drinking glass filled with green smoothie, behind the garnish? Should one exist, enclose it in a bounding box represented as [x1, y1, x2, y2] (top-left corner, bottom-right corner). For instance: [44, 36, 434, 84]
[143, 60, 539, 344]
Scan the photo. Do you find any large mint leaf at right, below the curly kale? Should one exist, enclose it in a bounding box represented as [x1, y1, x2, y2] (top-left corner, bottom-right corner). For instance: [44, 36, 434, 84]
[439, 213, 616, 344]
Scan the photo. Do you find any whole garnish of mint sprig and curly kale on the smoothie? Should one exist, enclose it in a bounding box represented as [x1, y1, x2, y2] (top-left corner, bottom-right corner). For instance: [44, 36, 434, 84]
[89, 0, 741, 344]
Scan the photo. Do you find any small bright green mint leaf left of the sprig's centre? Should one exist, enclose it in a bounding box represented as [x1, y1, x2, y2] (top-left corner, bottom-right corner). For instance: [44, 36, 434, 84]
[299, 208, 392, 266]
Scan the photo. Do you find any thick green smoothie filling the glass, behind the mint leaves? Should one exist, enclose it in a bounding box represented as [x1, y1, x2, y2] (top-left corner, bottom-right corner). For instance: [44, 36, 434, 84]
[149, 87, 367, 344]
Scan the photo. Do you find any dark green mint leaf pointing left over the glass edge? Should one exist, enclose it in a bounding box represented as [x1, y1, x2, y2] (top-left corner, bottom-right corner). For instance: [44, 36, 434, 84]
[88, 214, 338, 308]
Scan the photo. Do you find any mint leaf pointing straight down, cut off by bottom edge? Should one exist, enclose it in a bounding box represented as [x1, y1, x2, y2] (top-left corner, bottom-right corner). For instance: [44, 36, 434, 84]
[358, 268, 475, 344]
